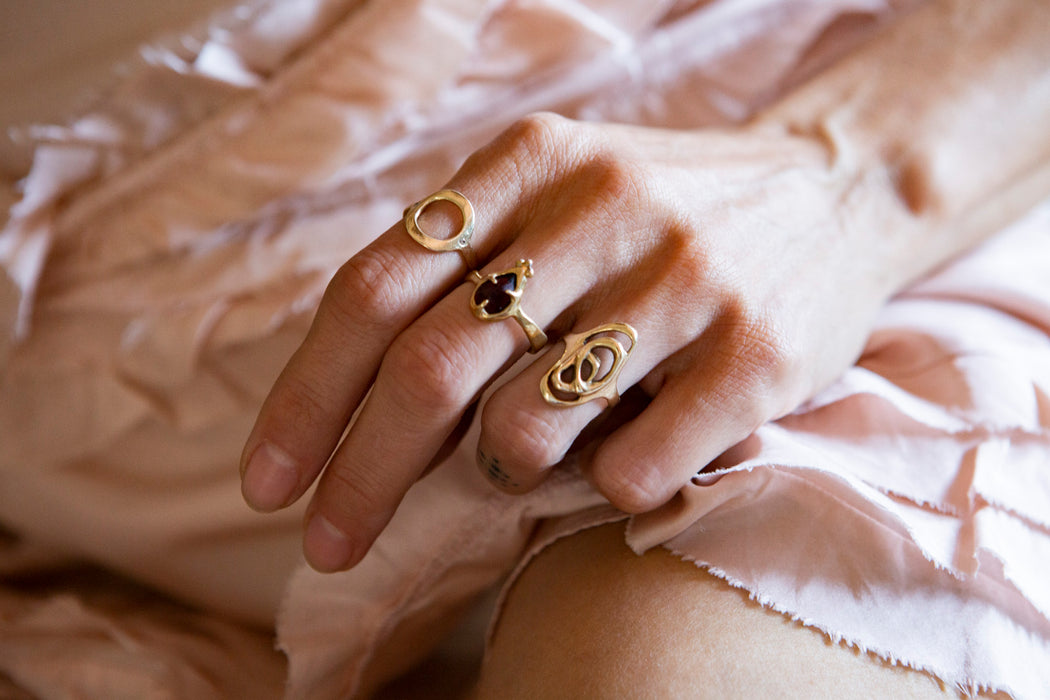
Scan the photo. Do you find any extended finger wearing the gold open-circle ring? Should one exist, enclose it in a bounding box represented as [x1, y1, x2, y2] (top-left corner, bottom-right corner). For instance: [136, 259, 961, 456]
[240, 116, 583, 511]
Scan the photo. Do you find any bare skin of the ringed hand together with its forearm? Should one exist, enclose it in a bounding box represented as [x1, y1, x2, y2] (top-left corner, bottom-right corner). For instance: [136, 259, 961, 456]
[242, 0, 1050, 688]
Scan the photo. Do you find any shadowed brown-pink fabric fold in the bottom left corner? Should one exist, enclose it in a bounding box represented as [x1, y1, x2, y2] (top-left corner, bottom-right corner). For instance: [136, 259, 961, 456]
[0, 573, 285, 700]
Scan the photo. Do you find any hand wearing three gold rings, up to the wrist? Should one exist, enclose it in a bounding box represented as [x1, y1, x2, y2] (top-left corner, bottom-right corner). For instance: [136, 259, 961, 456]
[243, 115, 906, 571]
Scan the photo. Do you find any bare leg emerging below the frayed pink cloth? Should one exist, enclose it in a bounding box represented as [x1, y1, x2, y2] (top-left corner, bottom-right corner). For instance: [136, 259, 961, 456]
[477, 524, 965, 699]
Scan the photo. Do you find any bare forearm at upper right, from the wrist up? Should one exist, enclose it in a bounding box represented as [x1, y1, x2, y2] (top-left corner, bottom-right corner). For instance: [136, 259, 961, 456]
[756, 0, 1050, 282]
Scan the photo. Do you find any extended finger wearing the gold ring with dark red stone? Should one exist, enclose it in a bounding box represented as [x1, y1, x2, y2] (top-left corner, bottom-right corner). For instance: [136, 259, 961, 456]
[303, 248, 589, 571]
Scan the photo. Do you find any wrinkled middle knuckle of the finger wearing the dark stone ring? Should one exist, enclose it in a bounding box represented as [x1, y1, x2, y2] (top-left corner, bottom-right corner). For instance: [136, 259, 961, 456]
[380, 324, 475, 412]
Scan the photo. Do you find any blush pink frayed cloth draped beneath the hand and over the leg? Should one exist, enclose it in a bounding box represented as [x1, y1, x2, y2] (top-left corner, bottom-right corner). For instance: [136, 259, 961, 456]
[0, 0, 1050, 698]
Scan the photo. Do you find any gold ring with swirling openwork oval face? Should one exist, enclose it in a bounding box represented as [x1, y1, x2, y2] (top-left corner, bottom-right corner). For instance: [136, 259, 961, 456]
[540, 323, 638, 406]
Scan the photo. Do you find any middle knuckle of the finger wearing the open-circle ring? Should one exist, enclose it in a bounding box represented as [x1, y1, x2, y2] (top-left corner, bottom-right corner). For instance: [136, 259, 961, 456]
[322, 247, 407, 327]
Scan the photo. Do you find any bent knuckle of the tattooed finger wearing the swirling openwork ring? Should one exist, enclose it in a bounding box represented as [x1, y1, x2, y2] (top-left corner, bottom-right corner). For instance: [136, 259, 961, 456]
[481, 395, 565, 470]
